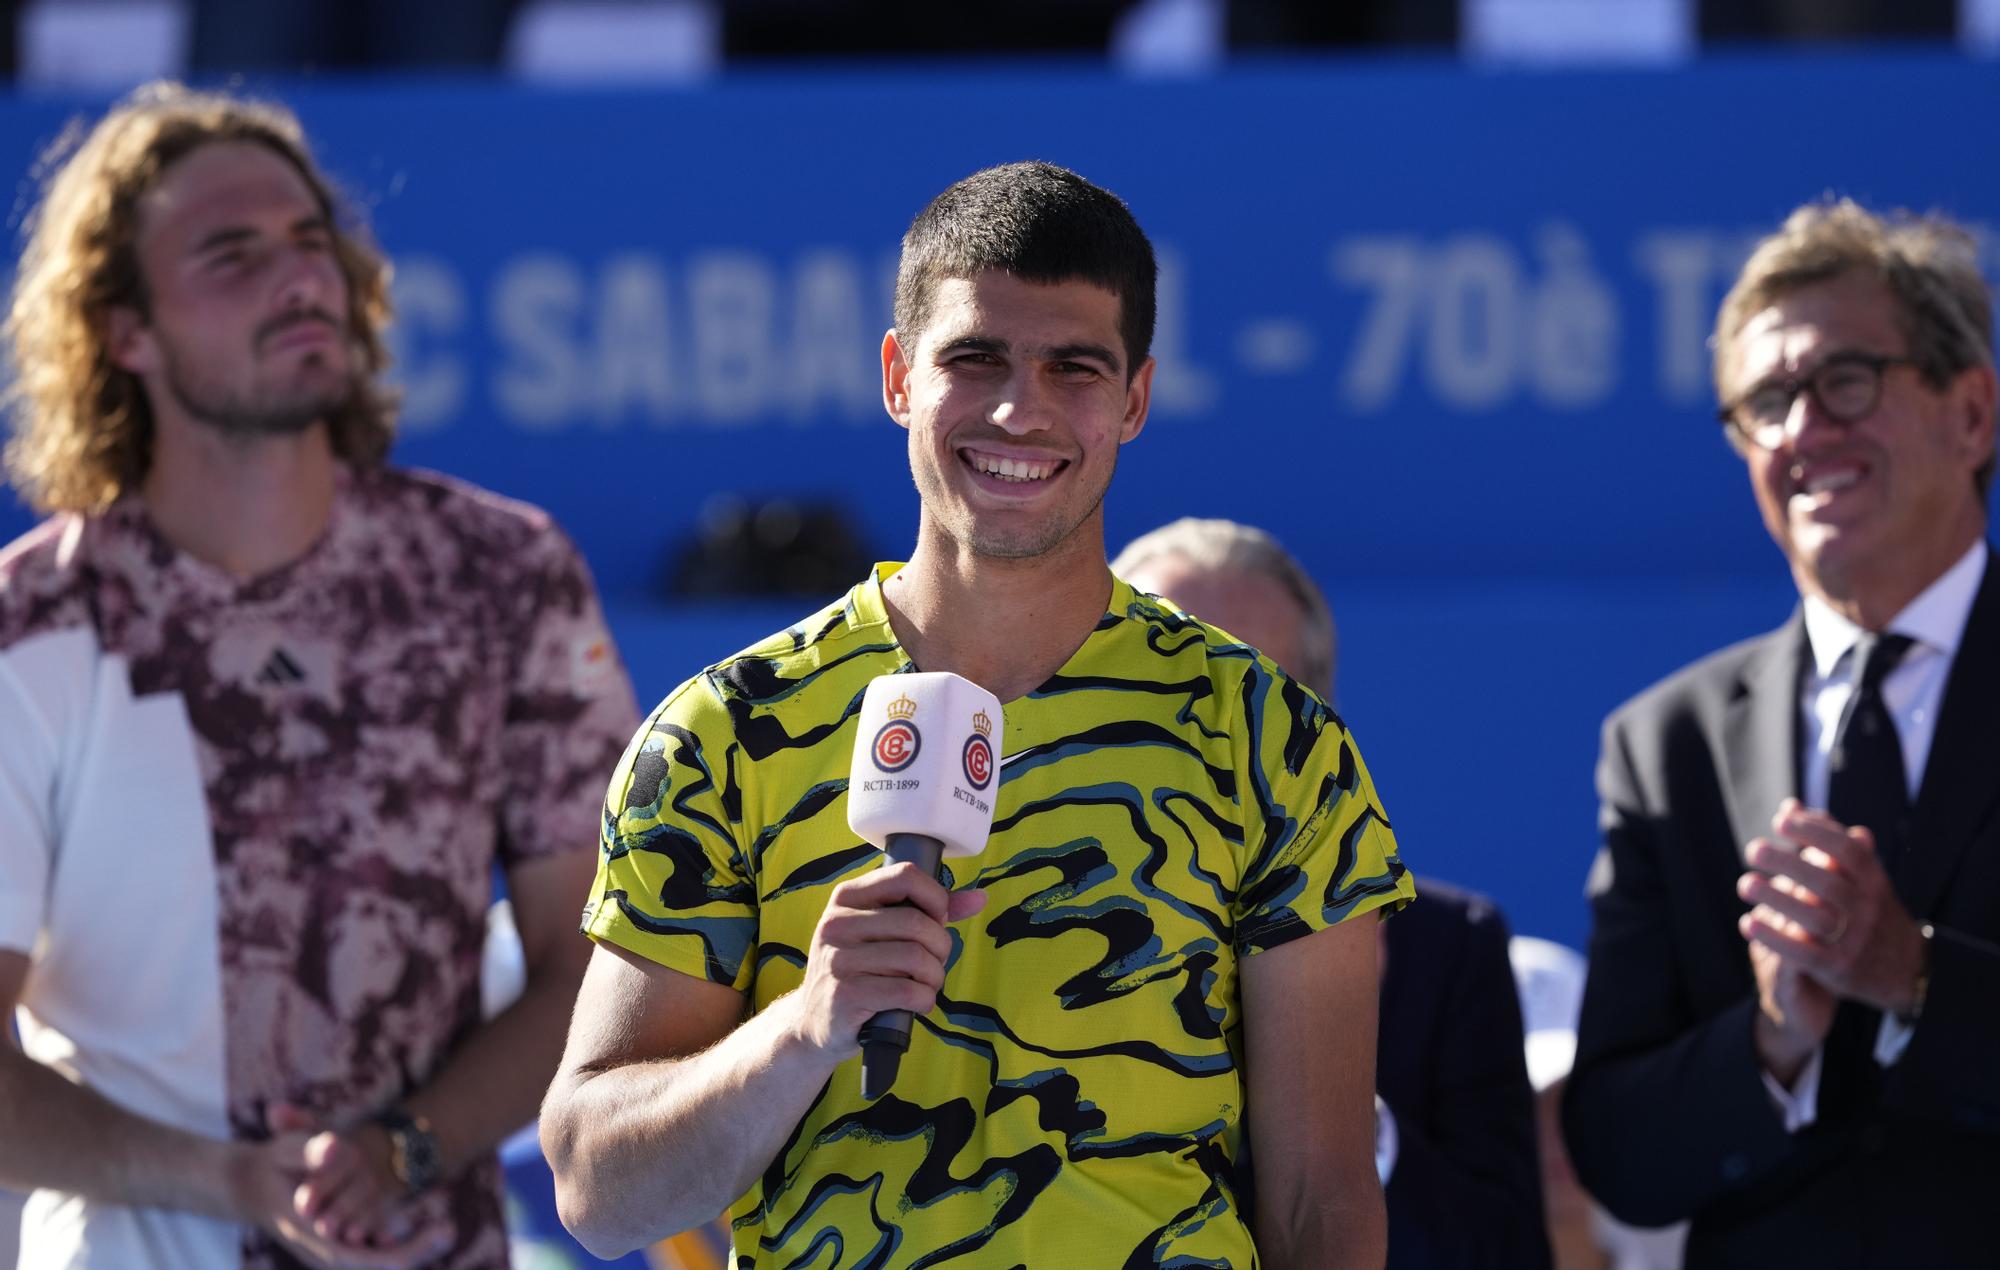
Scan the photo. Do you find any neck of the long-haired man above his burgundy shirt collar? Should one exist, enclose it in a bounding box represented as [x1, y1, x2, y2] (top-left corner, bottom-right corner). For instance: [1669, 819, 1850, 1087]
[142, 418, 336, 578]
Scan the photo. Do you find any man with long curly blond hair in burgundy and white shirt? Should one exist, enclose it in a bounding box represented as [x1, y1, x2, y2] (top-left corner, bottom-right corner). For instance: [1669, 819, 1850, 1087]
[0, 86, 634, 1268]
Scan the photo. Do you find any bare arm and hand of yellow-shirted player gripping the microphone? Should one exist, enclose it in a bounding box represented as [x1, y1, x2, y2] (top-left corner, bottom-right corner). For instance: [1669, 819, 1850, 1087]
[542, 864, 986, 1258]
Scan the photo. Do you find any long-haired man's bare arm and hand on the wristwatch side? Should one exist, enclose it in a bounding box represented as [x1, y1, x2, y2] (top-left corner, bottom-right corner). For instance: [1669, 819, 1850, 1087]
[290, 852, 596, 1242]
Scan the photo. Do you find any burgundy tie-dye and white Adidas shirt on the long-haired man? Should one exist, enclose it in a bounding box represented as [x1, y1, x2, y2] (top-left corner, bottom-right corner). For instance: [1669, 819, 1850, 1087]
[0, 470, 638, 1270]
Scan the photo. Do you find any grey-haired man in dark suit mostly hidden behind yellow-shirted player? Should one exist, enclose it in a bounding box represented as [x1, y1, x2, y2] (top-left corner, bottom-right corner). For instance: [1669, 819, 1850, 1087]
[1112, 518, 1550, 1270]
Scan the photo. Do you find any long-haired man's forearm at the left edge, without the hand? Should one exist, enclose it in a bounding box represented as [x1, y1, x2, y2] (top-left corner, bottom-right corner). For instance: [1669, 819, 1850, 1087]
[0, 1042, 242, 1220]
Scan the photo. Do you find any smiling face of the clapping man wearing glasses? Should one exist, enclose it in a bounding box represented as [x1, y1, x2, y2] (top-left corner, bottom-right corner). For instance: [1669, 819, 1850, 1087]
[1730, 272, 1994, 622]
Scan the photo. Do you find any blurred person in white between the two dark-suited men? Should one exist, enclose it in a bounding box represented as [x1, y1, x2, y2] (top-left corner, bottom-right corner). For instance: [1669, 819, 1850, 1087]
[1508, 934, 1688, 1270]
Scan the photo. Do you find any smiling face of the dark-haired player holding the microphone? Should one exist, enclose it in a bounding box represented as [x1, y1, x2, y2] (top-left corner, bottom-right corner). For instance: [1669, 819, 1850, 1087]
[882, 270, 1152, 560]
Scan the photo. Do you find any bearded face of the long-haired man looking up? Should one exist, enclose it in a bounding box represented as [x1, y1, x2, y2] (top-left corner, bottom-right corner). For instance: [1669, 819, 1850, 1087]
[110, 142, 360, 436]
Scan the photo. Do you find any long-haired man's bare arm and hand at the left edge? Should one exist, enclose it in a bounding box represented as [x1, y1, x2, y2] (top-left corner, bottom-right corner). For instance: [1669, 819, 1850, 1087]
[0, 952, 452, 1268]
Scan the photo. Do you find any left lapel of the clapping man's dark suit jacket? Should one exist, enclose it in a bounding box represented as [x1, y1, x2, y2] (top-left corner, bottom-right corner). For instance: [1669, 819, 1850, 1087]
[1722, 614, 1806, 858]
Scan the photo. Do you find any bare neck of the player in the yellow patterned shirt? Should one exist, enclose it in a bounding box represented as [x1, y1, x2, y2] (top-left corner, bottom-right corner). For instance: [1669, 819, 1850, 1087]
[882, 516, 1112, 704]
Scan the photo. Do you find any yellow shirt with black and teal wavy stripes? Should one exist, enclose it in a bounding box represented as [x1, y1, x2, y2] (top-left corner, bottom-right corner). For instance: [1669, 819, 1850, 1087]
[584, 566, 1414, 1270]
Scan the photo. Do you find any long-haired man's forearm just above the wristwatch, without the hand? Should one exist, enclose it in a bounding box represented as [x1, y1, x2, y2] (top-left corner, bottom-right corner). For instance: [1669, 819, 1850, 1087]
[390, 966, 582, 1174]
